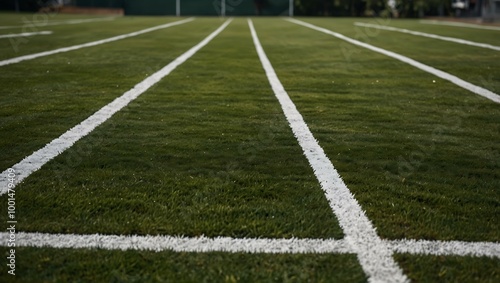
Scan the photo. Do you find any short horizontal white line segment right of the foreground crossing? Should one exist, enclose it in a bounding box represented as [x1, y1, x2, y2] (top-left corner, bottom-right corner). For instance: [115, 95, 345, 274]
[389, 239, 500, 259]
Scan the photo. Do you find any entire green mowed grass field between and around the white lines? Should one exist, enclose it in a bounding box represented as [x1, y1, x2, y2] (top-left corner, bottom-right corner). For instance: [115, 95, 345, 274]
[0, 13, 500, 282]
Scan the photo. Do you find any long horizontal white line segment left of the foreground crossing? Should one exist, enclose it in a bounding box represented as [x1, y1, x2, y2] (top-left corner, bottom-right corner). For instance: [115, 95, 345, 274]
[0, 232, 352, 254]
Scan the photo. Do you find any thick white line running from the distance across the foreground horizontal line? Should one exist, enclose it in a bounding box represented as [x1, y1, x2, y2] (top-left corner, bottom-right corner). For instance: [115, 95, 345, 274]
[248, 19, 408, 282]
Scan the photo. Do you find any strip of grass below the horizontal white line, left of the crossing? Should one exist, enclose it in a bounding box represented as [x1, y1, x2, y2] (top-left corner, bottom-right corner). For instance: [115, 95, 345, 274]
[0, 248, 366, 283]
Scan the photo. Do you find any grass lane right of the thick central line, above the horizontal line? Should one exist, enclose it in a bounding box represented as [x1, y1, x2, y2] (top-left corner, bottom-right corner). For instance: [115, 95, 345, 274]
[256, 19, 500, 241]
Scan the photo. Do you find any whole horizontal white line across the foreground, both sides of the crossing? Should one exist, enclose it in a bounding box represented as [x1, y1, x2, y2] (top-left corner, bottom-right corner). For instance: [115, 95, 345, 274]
[0, 232, 500, 259]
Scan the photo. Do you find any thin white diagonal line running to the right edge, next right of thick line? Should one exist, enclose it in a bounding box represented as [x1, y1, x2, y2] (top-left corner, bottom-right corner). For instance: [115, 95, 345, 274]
[285, 19, 500, 103]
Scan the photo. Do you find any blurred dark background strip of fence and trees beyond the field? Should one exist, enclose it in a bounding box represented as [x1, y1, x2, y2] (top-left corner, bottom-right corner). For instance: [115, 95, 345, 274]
[0, 0, 500, 21]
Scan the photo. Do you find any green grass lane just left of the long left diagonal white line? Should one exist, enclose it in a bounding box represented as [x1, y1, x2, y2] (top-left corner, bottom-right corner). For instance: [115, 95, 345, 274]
[0, 18, 218, 171]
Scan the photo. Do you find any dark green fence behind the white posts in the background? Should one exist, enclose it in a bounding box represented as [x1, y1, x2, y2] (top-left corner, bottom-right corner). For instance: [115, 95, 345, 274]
[72, 0, 290, 16]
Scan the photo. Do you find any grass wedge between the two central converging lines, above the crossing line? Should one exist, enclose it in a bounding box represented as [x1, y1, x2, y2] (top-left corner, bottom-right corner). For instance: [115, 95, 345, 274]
[6, 18, 342, 238]
